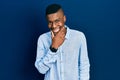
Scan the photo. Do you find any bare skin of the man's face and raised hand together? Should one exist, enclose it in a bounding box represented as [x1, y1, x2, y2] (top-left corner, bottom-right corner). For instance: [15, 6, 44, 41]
[47, 9, 66, 49]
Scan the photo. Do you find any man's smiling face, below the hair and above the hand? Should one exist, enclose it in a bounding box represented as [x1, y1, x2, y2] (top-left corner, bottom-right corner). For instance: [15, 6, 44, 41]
[47, 9, 66, 35]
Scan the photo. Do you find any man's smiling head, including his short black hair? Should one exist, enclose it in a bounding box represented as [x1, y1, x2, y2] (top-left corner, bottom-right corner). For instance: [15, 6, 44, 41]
[46, 4, 66, 34]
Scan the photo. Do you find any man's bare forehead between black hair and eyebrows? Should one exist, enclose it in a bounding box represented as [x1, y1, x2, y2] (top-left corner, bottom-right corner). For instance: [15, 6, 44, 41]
[47, 10, 64, 21]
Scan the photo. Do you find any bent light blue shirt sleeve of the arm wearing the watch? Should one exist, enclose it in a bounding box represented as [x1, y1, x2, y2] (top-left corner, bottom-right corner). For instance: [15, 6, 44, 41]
[35, 37, 57, 74]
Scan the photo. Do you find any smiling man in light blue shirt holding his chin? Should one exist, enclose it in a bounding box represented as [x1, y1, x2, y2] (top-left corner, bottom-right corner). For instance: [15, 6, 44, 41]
[35, 4, 90, 80]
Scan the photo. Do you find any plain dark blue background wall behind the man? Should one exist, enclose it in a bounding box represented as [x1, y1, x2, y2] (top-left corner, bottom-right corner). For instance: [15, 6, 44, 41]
[0, 0, 120, 80]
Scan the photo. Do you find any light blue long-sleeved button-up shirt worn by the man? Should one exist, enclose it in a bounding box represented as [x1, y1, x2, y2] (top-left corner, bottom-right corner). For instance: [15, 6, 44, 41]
[35, 26, 90, 80]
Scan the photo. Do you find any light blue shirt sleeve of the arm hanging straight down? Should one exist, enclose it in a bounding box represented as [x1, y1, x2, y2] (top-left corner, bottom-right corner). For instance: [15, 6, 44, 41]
[79, 33, 90, 80]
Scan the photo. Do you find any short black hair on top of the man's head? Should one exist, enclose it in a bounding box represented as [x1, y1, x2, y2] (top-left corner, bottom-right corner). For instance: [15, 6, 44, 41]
[46, 4, 62, 16]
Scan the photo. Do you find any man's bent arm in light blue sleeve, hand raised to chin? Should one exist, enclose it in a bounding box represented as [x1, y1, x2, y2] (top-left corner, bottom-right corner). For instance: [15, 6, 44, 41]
[35, 27, 66, 74]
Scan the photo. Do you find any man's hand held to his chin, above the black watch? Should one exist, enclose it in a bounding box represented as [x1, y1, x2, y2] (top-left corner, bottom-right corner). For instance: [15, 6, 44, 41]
[51, 27, 66, 49]
